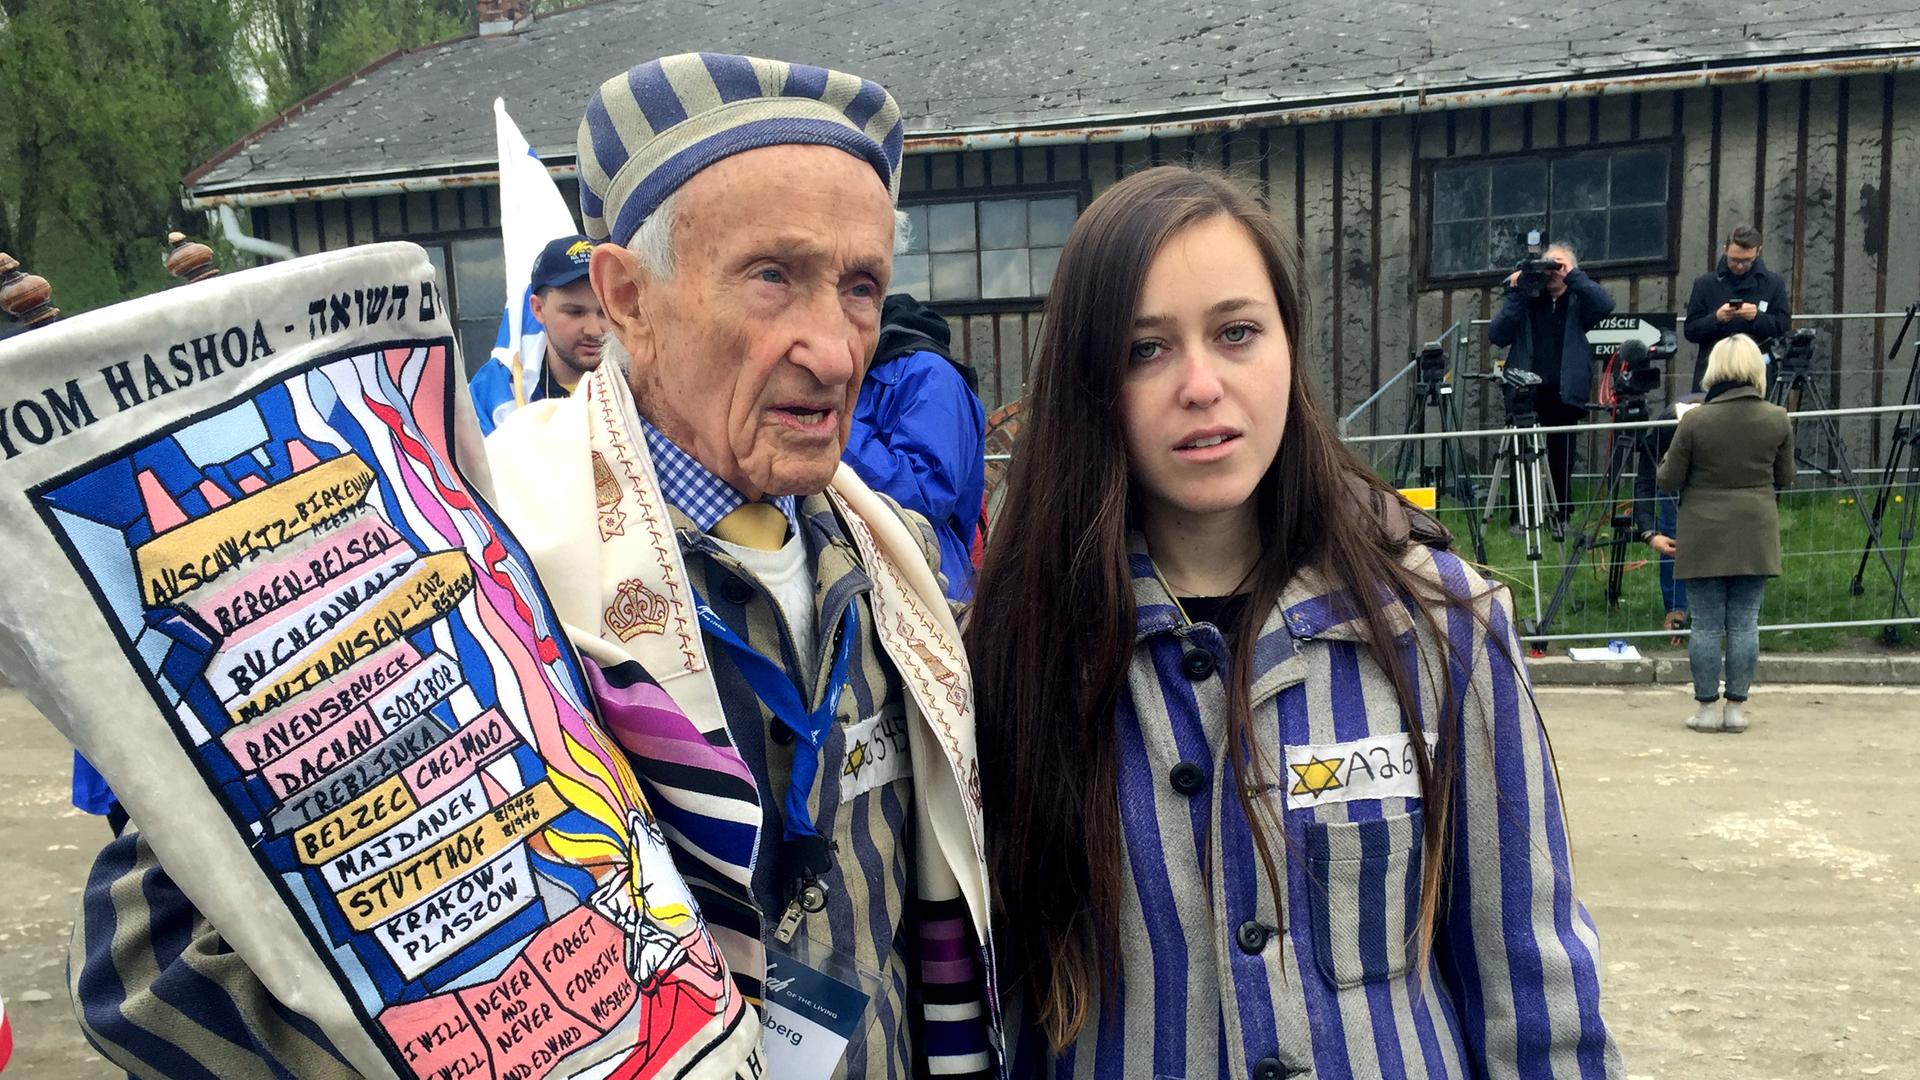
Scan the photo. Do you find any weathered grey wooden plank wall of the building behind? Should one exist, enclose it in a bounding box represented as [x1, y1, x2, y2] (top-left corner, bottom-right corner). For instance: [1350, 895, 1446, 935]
[236, 73, 1920, 441]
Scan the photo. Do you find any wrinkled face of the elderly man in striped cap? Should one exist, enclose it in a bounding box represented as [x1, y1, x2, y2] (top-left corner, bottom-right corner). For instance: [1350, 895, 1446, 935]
[593, 146, 893, 498]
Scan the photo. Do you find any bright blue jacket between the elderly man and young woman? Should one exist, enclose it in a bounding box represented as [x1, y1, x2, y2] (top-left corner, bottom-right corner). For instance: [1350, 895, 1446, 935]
[843, 294, 987, 600]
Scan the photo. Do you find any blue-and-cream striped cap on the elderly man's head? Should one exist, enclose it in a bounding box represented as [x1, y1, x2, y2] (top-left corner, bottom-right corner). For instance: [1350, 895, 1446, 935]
[580, 52, 906, 244]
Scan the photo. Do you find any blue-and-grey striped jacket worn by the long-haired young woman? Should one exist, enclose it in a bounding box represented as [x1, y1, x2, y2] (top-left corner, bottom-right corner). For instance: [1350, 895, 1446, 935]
[1008, 536, 1622, 1080]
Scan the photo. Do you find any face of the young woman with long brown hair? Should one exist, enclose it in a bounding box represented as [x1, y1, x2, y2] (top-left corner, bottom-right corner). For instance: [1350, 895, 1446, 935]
[1119, 215, 1292, 521]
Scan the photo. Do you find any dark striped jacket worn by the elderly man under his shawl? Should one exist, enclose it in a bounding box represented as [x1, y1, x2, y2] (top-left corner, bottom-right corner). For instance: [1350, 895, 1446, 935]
[67, 441, 996, 1080]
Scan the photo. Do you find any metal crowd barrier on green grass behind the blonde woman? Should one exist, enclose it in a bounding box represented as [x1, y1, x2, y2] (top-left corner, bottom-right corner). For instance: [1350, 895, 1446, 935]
[1348, 405, 1920, 642]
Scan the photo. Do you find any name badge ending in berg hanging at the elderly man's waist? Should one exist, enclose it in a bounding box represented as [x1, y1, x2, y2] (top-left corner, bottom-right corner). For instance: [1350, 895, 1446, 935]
[760, 936, 879, 1080]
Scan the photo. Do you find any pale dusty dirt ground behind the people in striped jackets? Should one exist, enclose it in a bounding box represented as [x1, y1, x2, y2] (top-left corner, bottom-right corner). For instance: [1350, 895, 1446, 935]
[0, 676, 1920, 1080]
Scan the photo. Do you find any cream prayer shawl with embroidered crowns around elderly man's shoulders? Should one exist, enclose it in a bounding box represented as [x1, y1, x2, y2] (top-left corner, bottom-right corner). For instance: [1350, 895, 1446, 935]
[488, 349, 993, 1007]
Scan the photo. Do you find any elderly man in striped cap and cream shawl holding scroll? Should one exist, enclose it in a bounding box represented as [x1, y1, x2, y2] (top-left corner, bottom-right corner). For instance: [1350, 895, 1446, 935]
[73, 54, 998, 1080]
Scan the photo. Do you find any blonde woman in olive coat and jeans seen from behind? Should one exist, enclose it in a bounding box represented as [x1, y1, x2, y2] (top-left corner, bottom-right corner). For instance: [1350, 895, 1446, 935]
[1659, 334, 1793, 732]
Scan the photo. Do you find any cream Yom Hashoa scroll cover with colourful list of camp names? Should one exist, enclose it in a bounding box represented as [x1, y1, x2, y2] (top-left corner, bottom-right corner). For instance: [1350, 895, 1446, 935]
[0, 244, 758, 1080]
